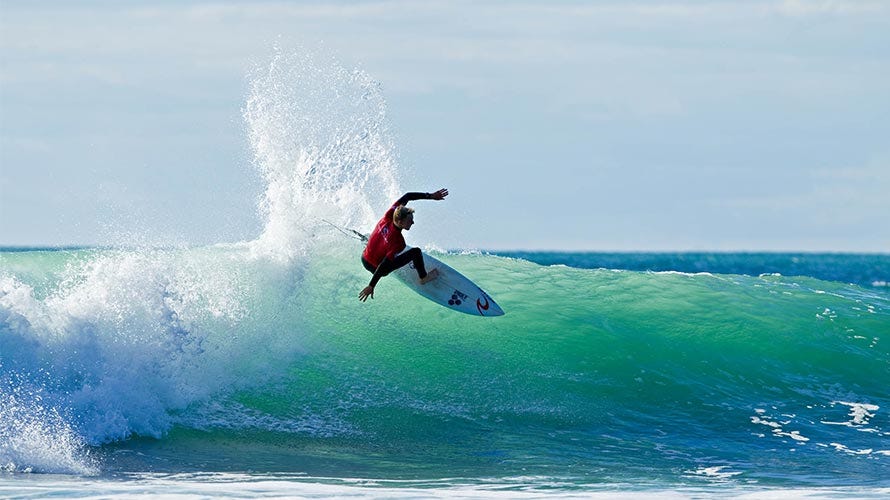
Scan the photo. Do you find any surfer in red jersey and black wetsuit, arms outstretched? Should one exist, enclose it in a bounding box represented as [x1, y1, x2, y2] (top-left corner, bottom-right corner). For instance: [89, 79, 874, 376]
[358, 188, 448, 302]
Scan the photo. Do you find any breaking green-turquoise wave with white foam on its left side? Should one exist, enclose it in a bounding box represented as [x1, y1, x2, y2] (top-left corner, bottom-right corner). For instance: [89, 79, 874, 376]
[0, 247, 890, 480]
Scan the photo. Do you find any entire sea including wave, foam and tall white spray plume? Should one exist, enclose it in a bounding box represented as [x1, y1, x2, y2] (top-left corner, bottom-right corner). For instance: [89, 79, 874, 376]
[0, 46, 890, 498]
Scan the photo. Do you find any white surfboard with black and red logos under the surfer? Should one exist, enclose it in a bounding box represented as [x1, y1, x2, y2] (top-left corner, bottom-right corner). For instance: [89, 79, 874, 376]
[322, 219, 504, 316]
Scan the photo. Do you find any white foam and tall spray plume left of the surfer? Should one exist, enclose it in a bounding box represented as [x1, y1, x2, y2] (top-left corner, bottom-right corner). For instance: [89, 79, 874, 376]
[0, 48, 412, 471]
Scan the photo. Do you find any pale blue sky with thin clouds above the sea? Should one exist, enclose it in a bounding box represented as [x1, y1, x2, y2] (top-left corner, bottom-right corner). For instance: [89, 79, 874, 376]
[0, 0, 890, 252]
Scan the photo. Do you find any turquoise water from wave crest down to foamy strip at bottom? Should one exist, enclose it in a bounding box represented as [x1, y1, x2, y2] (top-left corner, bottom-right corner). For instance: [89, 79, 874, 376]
[0, 245, 890, 496]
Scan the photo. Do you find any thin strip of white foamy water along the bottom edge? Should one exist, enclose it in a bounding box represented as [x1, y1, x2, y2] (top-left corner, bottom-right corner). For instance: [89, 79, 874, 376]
[0, 472, 890, 500]
